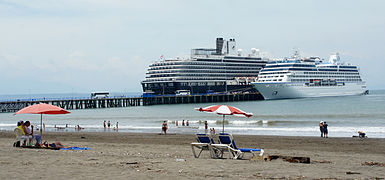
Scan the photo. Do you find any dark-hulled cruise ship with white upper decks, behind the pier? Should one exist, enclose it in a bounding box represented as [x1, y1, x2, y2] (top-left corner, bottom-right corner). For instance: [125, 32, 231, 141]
[141, 38, 268, 95]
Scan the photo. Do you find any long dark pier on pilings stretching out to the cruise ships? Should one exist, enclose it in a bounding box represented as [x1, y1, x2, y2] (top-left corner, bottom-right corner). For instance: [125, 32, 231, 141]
[0, 93, 263, 113]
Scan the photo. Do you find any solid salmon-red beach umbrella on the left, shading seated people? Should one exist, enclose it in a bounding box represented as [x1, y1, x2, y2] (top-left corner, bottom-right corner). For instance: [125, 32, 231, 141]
[15, 103, 70, 139]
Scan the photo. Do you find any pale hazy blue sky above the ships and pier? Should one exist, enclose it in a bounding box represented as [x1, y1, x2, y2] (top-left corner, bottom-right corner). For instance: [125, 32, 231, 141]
[0, 0, 385, 94]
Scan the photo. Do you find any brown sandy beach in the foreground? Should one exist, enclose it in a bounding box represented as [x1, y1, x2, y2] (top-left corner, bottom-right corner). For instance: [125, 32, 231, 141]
[0, 132, 385, 179]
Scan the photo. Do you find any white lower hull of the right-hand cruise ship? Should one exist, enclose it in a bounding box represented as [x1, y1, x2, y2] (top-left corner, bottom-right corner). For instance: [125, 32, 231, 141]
[252, 83, 367, 100]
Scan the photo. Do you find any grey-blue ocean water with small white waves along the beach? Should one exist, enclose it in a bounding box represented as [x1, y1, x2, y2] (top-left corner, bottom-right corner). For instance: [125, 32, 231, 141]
[0, 90, 385, 138]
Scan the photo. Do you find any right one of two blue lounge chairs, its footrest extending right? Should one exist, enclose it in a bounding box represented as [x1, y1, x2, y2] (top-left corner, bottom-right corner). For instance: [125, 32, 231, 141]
[212, 133, 264, 159]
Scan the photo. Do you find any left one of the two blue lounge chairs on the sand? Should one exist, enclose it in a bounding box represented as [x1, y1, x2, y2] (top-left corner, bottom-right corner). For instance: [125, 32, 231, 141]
[191, 134, 215, 158]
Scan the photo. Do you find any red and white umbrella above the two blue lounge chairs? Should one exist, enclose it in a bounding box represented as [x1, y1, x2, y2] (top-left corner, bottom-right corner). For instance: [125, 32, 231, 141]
[195, 105, 253, 133]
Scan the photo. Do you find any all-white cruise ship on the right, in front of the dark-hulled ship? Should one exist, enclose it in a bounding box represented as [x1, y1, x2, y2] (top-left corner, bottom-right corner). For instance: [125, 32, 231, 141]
[251, 52, 368, 99]
